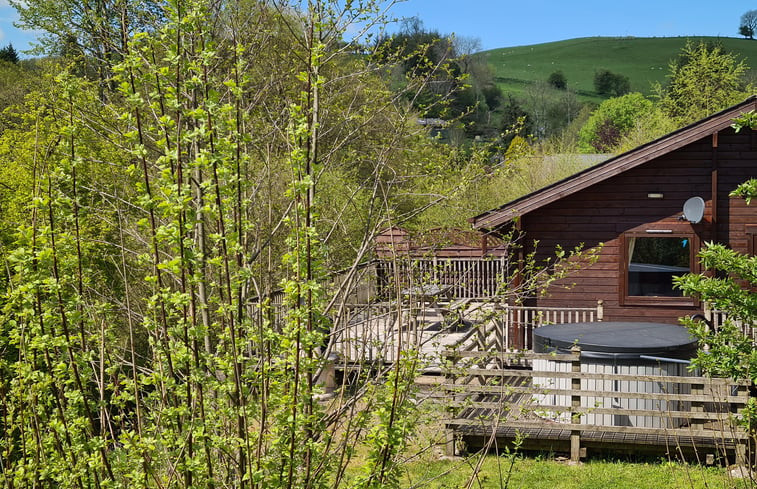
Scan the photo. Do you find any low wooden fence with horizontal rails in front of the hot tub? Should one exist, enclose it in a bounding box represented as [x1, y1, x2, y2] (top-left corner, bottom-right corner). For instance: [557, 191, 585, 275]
[443, 348, 749, 464]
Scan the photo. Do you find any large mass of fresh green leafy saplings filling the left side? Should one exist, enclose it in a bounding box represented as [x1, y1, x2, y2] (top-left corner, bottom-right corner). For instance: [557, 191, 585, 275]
[0, 1, 444, 488]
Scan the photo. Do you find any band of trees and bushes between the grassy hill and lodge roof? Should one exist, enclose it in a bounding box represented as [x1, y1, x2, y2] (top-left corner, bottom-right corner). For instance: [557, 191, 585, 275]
[368, 24, 752, 158]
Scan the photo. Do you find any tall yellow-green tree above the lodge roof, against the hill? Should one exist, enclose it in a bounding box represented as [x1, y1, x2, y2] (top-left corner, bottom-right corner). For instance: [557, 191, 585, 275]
[655, 42, 751, 124]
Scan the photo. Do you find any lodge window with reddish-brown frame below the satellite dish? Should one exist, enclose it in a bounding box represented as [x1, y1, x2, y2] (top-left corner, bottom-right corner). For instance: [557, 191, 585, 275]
[622, 234, 695, 304]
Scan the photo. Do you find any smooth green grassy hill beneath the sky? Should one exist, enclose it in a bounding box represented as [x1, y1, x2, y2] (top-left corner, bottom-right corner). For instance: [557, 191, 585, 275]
[482, 37, 757, 102]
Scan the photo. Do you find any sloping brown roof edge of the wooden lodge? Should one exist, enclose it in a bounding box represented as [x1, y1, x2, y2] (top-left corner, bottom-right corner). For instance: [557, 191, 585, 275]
[469, 96, 757, 230]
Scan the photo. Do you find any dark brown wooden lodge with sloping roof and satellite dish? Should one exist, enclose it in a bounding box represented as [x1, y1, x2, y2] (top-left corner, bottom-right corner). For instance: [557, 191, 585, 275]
[471, 97, 757, 323]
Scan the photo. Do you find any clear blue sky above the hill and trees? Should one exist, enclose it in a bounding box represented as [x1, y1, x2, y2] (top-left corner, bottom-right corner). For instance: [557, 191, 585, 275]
[0, 0, 757, 55]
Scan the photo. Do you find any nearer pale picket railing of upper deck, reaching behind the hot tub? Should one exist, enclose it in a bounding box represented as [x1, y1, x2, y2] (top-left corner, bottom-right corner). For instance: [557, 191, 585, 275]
[251, 298, 603, 364]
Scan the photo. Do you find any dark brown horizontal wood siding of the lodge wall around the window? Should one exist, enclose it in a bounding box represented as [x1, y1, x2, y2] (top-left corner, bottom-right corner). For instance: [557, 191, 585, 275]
[521, 129, 757, 322]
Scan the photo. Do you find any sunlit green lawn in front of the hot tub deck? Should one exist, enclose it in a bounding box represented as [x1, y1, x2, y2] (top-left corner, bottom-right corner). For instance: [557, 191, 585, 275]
[348, 401, 753, 489]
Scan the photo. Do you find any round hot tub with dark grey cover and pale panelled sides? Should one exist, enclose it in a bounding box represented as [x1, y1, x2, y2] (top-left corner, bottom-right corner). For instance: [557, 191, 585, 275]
[533, 322, 697, 428]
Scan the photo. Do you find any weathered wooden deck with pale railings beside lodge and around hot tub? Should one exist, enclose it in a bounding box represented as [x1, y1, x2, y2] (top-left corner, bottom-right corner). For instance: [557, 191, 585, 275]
[251, 288, 754, 463]
